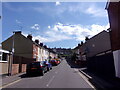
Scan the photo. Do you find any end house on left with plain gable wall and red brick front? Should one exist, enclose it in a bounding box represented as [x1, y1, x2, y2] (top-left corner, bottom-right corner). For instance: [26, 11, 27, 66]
[2, 31, 39, 60]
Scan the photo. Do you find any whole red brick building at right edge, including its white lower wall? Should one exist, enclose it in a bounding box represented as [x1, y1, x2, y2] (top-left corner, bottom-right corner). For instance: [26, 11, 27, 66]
[106, 0, 120, 78]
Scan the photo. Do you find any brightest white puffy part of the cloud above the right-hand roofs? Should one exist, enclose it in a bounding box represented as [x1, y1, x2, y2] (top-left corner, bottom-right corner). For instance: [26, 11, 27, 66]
[46, 23, 109, 41]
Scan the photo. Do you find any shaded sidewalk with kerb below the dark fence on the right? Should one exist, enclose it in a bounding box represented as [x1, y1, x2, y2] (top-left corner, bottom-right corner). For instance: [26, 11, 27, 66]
[79, 68, 120, 90]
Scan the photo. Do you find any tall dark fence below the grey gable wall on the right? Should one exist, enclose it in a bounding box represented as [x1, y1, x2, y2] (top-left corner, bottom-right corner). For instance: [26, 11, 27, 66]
[87, 53, 115, 77]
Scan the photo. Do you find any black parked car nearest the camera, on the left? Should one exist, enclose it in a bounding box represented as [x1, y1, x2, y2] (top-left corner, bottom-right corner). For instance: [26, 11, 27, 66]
[26, 61, 47, 76]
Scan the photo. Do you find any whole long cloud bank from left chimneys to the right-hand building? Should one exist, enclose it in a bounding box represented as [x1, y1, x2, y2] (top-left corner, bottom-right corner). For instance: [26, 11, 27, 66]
[22, 23, 109, 42]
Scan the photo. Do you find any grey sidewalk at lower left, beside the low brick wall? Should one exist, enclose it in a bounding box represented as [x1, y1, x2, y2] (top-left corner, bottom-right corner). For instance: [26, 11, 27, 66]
[0, 72, 25, 87]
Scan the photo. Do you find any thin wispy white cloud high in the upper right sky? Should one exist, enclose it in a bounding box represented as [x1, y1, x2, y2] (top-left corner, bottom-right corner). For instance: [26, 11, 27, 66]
[67, 2, 108, 17]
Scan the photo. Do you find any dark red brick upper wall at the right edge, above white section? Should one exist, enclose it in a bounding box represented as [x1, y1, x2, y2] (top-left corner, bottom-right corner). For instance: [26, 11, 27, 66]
[108, 2, 120, 51]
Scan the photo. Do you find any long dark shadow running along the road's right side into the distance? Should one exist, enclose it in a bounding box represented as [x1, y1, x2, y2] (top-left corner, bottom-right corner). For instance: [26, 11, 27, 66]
[66, 59, 120, 90]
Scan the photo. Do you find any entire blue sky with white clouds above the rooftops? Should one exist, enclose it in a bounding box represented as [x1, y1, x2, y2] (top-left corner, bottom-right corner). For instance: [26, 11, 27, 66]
[2, 1, 109, 48]
